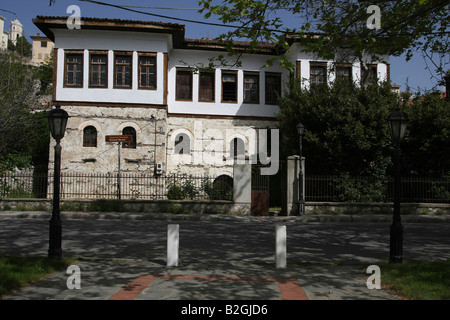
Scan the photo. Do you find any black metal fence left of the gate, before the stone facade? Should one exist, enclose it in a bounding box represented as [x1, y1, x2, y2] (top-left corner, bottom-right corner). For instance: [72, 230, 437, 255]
[0, 172, 233, 200]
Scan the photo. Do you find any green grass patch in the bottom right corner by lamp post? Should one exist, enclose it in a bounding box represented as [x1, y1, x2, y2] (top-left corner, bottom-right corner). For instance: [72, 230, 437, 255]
[380, 260, 450, 300]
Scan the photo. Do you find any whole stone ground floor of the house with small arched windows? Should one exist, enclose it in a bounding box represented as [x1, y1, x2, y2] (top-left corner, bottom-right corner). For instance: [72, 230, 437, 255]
[49, 105, 278, 180]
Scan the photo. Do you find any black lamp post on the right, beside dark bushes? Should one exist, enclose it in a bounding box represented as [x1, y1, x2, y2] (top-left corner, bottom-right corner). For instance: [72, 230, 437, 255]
[388, 108, 409, 263]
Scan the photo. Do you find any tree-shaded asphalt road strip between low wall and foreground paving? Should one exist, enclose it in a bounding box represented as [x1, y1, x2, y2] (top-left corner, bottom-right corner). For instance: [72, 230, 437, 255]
[0, 219, 450, 263]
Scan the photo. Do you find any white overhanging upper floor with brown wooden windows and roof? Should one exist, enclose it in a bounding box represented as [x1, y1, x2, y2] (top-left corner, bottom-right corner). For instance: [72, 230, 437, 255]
[34, 16, 389, 118]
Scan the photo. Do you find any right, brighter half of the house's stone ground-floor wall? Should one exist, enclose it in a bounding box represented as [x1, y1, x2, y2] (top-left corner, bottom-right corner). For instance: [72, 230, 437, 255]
[167, 116, 277, 176]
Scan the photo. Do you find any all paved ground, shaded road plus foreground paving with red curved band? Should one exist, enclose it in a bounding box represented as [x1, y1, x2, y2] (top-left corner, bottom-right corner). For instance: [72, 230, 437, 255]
[0, 214, 450, 300]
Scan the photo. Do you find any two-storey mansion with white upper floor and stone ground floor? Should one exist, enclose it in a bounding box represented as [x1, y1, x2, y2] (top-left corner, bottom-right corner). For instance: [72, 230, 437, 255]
[33, 16, 389, 176]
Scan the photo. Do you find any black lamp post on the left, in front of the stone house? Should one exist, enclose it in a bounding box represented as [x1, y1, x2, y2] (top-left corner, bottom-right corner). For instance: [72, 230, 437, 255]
[48, 105, 69, 259]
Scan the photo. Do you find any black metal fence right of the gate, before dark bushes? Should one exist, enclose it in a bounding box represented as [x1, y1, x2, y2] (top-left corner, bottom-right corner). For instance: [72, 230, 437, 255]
[305, 176, 450, 203]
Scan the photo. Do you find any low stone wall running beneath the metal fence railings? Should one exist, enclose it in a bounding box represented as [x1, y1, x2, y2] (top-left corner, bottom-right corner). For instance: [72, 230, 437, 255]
[0, 199, 450, 216]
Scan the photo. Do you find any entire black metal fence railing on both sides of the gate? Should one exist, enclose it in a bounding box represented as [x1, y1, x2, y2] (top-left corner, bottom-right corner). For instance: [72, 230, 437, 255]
[0, 172, 450, 203]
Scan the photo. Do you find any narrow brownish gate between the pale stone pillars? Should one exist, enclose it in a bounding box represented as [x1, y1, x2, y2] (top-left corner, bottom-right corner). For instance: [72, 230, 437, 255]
[251, 165, 270, 216]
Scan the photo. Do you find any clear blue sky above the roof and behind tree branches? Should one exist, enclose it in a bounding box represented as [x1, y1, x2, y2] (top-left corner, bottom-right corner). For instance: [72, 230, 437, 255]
[0, 0, 450, 93]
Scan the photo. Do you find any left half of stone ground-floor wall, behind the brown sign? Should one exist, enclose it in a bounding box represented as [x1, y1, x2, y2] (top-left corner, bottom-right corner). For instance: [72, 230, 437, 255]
[49, 106, 167, 173]
